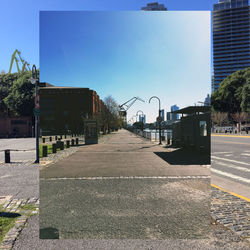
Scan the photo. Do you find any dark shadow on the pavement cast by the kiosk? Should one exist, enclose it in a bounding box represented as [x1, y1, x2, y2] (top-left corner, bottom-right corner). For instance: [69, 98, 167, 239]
[154, 149, 210, 165]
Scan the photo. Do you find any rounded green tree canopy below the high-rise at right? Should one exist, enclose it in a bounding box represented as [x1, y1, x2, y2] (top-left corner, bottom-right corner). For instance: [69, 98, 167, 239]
[211, 67, 250, 114]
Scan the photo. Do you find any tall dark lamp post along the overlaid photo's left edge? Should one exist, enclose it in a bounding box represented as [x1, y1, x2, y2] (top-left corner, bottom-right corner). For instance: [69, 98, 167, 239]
[30, 65, 40, 163]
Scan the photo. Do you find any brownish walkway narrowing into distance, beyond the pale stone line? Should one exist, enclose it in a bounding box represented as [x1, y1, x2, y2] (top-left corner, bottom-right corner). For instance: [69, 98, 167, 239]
[40, 129, 210, 179]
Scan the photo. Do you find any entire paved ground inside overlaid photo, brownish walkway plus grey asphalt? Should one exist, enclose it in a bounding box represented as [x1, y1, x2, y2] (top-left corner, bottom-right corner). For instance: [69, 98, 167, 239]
[40, 130, 210, 239]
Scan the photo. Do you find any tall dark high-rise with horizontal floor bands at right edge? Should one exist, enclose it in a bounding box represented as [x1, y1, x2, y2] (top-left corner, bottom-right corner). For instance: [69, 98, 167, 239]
[212, 0, 250, 91]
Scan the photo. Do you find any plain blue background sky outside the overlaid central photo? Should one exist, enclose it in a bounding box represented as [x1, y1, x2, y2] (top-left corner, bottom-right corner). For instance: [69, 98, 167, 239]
[0, 0, 218, 122]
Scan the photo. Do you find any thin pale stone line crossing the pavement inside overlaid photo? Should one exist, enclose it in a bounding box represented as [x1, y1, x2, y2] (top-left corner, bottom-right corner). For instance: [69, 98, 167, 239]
[40, 175, 211, 181]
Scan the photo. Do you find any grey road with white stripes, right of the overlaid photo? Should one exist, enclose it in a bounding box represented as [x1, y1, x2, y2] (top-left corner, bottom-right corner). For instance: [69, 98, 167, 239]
[211, 135, 250, 198]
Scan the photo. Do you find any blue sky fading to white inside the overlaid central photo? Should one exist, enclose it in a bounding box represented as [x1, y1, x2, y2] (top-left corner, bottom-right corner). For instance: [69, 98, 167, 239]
[40, 11, 211, 122]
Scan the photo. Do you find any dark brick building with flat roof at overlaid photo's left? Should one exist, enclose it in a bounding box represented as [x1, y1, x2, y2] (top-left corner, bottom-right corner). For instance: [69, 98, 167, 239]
[39, 87, 105, 135]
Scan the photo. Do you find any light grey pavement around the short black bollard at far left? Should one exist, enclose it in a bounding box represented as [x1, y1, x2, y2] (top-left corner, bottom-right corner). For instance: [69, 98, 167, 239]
[0, 138, 36, 163]
